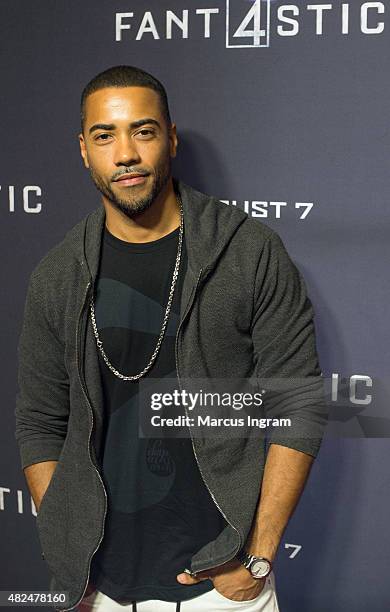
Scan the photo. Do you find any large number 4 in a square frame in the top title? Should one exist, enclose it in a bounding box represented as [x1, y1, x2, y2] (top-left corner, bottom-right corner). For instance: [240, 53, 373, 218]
[226, 0, 270, 49]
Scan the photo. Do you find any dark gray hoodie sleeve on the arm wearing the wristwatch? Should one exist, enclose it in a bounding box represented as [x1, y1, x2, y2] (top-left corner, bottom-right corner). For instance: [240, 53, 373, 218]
[251, 230, 328, 457]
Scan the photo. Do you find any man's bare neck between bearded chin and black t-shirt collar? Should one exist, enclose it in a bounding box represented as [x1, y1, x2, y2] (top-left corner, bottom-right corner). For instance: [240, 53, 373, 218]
[103, 180, 180, 242]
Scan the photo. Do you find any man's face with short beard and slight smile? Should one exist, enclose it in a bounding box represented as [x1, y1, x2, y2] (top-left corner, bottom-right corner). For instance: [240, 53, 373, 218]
[79, 87, 177, 218]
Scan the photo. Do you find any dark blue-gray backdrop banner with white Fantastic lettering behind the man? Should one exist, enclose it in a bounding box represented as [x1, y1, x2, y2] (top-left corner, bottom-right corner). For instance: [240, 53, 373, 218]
[0, 0, 390, 612]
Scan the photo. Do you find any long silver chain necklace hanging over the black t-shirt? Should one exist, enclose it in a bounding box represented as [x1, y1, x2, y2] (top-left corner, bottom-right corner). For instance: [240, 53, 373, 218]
[90, 194, 184, 380]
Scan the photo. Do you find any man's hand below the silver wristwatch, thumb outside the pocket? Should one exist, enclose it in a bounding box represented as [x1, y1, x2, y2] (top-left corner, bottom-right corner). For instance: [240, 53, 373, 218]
[176, 560, 265, 601]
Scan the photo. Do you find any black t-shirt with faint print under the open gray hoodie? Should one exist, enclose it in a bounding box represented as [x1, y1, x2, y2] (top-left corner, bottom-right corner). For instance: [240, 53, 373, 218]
[90, 222, 226, 602]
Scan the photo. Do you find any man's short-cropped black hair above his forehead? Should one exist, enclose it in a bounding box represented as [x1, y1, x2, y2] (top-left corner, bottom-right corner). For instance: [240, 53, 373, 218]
[80, 65, 172, 131]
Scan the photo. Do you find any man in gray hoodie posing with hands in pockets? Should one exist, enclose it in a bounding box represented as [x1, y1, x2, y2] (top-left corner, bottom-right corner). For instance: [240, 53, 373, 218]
[16, 66, 326, 612]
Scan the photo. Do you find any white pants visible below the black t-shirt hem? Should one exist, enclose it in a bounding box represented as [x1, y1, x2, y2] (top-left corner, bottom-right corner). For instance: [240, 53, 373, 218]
[77, 572, 279, 612]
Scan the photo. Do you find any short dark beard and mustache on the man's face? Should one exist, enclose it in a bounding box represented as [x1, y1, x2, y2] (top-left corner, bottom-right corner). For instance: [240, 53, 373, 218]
[90, 155, 171, 219]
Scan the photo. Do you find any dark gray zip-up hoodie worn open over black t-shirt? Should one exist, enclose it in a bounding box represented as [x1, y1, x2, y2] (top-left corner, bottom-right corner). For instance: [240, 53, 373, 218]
[15, 179, 327, 610]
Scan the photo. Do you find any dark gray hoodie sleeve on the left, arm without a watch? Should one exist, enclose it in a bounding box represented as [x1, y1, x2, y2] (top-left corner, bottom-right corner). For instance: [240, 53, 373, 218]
[15, 272, 69, 469]
